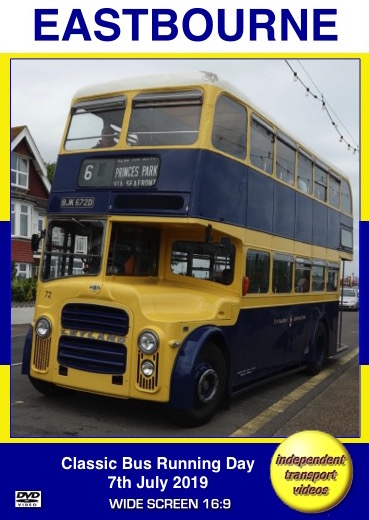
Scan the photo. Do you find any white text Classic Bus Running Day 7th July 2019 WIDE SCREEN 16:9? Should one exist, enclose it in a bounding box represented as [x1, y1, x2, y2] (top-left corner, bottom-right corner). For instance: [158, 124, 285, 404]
[61, 456, 255, 509]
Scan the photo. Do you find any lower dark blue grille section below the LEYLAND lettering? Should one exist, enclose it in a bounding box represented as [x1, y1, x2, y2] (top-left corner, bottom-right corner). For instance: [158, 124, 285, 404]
[58, 336, 127, 374]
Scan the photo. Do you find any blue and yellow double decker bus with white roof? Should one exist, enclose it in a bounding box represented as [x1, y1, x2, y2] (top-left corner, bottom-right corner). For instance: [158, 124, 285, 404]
[23, 72, 353, 426]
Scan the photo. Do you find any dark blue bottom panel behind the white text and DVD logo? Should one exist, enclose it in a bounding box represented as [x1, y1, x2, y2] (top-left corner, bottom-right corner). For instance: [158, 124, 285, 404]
[1, 442, 369, 520]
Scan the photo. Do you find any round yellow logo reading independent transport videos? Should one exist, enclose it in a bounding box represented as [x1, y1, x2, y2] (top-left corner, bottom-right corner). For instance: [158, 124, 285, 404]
[270, 431, 352, 513]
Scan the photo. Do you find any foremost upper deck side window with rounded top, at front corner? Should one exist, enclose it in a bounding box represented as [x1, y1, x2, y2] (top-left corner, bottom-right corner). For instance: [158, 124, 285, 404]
[211, 96, 247, 159]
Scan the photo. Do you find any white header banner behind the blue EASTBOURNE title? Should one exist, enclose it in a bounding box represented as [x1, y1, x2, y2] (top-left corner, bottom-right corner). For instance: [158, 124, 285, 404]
[0, 0, 369, 54]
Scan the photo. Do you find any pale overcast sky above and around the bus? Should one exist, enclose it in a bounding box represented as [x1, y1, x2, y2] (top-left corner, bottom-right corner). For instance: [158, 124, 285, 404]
[11, 58, 360, 276]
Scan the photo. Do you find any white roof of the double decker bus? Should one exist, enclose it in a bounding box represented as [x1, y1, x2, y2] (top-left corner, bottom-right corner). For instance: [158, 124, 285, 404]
[73, 71, 350, 184]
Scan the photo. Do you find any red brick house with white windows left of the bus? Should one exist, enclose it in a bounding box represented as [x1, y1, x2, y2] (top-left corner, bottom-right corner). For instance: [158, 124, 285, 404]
[11, 126, 50, 278]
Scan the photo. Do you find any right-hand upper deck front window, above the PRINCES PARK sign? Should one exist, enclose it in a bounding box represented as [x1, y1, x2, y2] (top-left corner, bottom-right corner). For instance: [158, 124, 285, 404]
[127, 90, 202, 146]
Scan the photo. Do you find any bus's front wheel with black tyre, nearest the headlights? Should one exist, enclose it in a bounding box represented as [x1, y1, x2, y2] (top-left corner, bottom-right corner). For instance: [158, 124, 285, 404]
[171, 342, 227, 428]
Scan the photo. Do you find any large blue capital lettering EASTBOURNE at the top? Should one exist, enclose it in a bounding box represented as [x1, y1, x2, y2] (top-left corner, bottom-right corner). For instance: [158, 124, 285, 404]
[34, 7, 338, 42]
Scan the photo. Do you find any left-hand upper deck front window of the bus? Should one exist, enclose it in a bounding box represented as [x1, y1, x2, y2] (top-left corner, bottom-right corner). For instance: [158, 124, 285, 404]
[64, 96, 126, 150]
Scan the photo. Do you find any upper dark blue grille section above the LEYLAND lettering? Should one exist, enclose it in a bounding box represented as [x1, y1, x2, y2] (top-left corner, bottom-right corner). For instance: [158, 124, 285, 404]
[61, 303, 129, 336]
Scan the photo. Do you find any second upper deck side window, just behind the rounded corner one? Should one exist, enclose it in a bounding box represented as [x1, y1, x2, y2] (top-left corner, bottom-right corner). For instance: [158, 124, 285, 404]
[250, 115, 274, 173]
